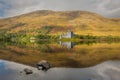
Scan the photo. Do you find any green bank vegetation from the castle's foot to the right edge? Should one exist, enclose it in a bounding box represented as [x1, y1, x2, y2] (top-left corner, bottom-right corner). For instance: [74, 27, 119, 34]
[60, 35, 120, 42]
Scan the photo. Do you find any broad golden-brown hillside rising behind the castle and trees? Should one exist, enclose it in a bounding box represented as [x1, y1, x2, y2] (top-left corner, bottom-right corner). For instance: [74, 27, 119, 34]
[0, 10, 120, 36]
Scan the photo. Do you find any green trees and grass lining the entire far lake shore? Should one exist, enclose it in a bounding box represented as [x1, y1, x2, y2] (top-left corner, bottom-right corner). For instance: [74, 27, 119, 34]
[0, 33, 120, 43]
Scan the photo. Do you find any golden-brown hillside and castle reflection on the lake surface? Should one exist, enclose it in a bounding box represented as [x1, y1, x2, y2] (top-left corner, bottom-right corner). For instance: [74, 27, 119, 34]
[0, 41, 120, 68]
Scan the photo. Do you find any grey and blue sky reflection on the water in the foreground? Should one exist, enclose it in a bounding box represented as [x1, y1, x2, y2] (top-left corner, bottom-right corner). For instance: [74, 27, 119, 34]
[0, 60, 120, 80]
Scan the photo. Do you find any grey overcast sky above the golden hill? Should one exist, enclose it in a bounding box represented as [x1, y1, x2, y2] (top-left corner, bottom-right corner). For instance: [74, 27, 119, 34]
[0, 0, 120, 18]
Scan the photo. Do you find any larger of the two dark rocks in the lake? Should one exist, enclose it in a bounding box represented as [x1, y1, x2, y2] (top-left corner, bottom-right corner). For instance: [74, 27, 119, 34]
[37, 60, 51, 70]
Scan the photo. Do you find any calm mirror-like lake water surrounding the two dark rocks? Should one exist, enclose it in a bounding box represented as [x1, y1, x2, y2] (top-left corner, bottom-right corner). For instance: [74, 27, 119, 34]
[0, 41, 120, 80]
